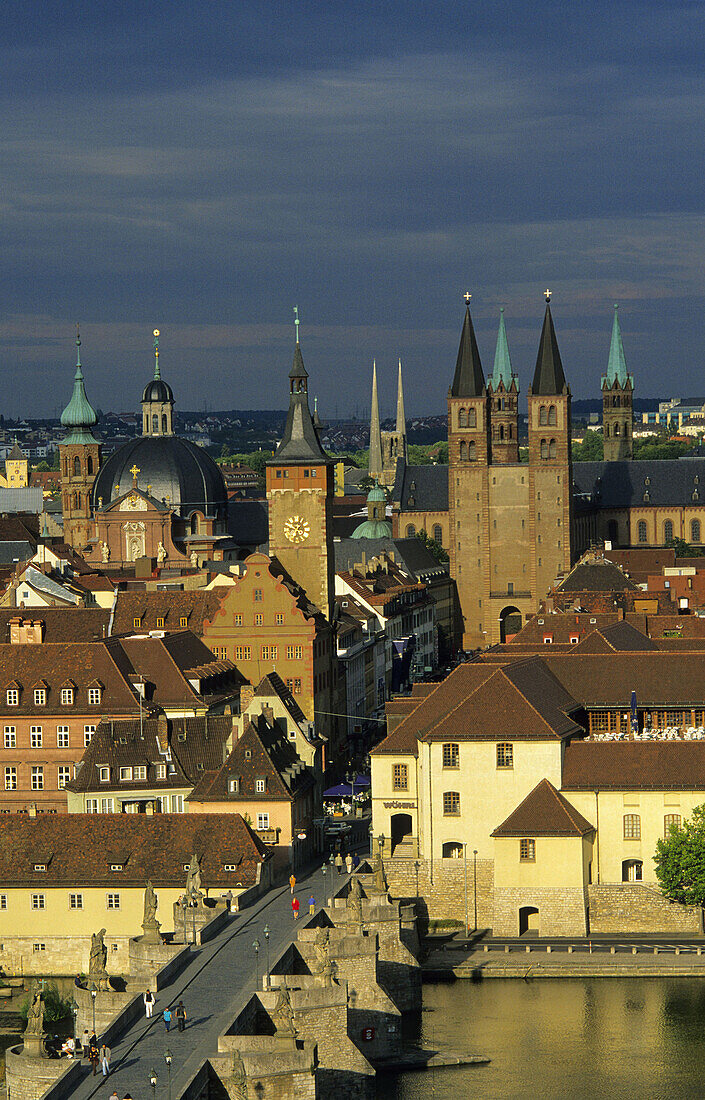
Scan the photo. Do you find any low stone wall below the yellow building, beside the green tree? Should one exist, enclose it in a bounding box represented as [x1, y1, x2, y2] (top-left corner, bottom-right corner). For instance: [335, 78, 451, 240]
[587, 882, 703, 936]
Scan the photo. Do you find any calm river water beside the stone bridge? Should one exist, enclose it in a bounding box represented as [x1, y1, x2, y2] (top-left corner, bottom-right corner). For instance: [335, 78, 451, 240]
[377, 970, 705, 1100]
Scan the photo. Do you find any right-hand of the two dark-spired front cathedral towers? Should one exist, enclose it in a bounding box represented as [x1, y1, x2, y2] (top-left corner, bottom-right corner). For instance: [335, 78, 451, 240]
[529, 290, 573, 598]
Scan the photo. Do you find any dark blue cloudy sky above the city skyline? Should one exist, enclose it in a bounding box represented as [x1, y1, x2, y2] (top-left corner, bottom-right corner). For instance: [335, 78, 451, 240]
[0, 0, 705, 416]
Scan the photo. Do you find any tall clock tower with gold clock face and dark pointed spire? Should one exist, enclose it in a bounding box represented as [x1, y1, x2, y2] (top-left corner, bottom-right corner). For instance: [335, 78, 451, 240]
[266, 310, 335, 618]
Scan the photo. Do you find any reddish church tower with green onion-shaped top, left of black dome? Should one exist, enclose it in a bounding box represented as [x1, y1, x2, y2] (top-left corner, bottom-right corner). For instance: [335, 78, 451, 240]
[58, 326, 101, 550]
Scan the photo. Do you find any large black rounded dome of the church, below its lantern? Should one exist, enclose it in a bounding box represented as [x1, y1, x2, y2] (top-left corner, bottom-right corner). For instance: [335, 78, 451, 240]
[92, 433, 228, 519]
